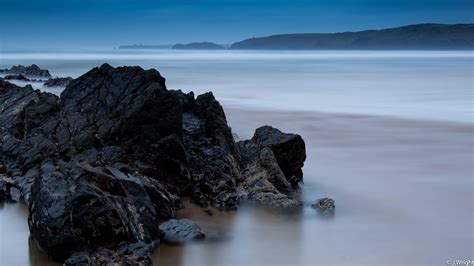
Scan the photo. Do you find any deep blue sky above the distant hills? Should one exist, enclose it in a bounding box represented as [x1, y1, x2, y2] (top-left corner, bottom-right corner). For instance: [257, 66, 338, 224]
[0, 0, 474, 51]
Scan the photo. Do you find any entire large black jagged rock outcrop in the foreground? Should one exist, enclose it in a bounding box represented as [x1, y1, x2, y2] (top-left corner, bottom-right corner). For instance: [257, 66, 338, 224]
[0, 64, 306, 265]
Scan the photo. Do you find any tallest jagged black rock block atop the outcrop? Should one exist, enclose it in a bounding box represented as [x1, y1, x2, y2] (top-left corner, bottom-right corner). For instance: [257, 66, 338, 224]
[56, 62, 178, 150]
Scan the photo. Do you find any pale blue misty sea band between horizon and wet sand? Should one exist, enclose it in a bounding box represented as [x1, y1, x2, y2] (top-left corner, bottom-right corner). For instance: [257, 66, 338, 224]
[0, 50, 474, 123]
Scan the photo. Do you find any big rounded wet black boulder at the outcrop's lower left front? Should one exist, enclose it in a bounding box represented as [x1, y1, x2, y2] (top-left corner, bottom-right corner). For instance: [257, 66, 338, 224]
[28, 162, 175, 260]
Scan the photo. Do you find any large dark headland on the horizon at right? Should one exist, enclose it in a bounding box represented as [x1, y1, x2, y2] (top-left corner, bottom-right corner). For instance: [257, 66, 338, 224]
[231, 24, 474, 50]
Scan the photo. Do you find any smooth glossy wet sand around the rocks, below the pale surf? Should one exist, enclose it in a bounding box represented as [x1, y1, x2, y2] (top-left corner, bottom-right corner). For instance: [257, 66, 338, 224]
[0, 106, 474, 265]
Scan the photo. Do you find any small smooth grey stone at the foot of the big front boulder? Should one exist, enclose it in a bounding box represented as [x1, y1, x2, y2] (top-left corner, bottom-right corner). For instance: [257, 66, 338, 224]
[160, 219, 206, 244]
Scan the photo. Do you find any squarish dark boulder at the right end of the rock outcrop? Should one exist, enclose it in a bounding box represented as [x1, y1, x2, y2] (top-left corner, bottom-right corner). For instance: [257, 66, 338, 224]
[237, 126, 306, 208]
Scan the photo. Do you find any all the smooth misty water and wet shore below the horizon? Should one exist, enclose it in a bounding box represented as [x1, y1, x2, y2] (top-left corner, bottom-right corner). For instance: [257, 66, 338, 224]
[0, 51, 474, 266]
